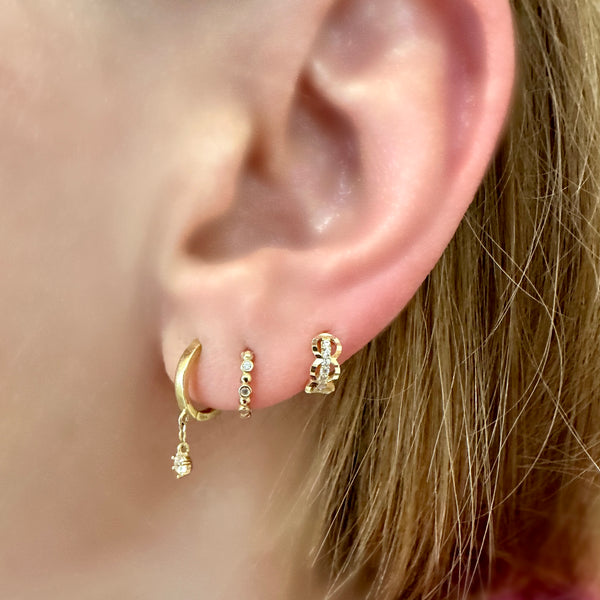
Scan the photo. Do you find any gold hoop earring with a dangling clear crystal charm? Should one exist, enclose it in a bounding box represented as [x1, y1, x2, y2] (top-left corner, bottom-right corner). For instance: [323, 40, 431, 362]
[171, 340, 221, 479]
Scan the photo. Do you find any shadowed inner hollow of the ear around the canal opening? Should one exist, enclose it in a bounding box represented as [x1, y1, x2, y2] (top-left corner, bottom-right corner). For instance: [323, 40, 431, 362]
[186, 72, 363, 263]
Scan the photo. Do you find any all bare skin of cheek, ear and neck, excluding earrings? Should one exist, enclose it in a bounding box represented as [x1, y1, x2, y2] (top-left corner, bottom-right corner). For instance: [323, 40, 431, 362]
[0, 0, 513, 599]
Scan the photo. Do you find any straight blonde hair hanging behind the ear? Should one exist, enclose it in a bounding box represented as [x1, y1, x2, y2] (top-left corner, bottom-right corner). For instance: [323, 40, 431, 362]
[313, 0, 600, 600]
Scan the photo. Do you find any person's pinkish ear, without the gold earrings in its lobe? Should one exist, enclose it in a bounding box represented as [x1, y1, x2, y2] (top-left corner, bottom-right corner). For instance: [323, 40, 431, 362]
[160, 0, 514, 409]
